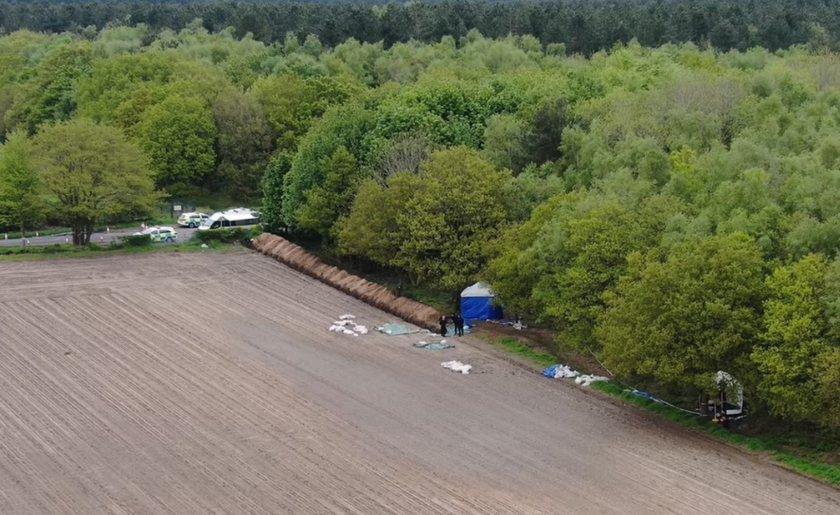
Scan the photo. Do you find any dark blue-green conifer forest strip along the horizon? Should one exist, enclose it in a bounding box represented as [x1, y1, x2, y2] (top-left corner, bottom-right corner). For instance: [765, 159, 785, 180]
[0, 0, 840, 55]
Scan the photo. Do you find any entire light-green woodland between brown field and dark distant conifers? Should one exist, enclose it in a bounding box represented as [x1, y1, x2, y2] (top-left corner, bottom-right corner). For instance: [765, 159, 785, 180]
[0, 3, 840, 434]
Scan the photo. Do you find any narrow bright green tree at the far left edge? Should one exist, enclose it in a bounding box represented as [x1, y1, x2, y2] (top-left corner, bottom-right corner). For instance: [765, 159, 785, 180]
[0, 129, 46, 238]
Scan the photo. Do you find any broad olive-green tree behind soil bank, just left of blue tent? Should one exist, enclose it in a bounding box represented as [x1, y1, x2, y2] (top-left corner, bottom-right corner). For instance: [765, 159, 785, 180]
[338, 147, 509, 292]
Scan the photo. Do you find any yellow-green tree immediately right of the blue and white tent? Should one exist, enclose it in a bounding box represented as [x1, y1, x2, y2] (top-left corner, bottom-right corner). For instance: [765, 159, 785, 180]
[486, 194, 672, 349]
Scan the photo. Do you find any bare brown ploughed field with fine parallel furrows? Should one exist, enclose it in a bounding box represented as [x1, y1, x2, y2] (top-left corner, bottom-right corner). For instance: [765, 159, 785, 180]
[0, 252, 840, 514]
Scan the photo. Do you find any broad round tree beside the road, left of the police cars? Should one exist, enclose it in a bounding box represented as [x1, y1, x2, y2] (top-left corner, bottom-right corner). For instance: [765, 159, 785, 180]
[34, 119, 160, 245]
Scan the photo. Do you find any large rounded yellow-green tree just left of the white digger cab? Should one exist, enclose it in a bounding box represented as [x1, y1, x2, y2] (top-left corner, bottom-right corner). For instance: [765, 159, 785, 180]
[596, 233, 764, 393]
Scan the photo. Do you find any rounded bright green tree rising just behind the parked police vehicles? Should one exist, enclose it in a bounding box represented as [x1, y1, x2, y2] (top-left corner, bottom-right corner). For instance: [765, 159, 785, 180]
[139, 95, 216, 192]
